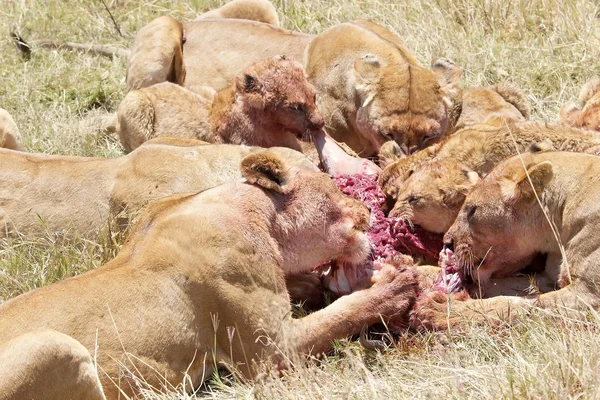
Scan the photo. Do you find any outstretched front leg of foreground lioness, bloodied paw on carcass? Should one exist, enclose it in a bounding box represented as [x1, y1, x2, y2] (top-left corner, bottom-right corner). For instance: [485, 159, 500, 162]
[284, 265, 418, 354]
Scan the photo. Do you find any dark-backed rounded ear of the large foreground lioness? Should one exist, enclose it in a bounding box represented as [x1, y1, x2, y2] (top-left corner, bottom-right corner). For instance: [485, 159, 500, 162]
[240, 150, 290, 193]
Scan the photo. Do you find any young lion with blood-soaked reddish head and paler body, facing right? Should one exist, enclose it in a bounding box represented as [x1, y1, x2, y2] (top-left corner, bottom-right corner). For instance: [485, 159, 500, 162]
[117, 56, 324, 151]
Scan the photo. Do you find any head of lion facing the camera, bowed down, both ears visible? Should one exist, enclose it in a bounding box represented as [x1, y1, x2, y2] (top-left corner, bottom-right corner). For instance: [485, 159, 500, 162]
[354, 55, 461, 155]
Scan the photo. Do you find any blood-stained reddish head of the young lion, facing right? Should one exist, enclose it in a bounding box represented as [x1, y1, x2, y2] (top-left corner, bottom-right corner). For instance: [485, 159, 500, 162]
[237, 56, 324, 139]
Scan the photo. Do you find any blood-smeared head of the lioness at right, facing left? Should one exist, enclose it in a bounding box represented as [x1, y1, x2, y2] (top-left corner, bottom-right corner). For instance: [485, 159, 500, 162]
[444, 155, 553, 286]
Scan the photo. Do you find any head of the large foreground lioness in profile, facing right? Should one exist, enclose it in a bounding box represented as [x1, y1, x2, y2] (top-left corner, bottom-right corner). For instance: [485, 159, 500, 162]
[242, 150, 371, 273]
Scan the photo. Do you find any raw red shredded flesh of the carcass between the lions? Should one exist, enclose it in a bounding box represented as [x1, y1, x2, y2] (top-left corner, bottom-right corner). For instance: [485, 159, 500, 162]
[320, 174, 442, 294]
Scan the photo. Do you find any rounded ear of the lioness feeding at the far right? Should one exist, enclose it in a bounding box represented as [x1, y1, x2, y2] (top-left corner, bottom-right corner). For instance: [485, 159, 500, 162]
[503, 161, 554, 208]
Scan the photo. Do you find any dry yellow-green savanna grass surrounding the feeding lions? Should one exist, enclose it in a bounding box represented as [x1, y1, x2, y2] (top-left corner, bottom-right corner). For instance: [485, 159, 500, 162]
[0, 0, 600, 399]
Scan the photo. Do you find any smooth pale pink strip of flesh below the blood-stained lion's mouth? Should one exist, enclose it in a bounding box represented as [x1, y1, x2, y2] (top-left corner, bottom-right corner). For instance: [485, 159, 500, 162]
[313, 129, 381, 177]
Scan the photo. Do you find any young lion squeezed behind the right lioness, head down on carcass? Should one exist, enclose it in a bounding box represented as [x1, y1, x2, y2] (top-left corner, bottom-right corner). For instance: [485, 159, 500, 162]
[379, 122, 600, 228]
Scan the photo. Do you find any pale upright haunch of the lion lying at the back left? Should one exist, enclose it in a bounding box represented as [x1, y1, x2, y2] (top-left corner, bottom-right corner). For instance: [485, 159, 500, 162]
[126, 16, 185, 91]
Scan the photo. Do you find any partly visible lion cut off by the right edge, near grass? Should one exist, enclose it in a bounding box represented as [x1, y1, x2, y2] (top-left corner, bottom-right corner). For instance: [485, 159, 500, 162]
[560, 76, 600, 131]
